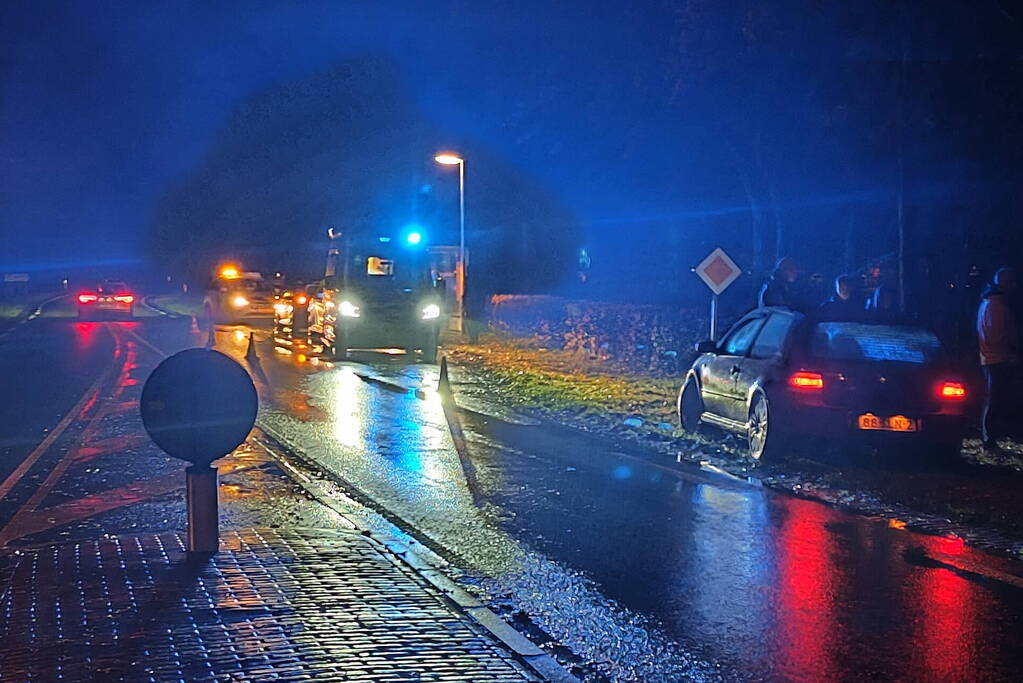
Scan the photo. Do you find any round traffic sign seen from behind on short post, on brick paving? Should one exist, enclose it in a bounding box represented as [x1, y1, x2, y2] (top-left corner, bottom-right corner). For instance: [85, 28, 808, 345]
[139, 349, 259, 554]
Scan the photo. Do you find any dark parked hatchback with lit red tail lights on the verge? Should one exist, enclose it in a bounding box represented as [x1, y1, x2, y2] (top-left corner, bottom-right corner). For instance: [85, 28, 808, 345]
[678, 308, 968, 460]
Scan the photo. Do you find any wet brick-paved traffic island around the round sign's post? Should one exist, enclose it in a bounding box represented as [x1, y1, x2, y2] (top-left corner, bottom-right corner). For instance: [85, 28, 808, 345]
[0, 529, 536, 681]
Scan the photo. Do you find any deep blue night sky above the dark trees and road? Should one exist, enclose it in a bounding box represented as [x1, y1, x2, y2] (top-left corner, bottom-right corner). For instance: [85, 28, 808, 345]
[0, 0, 1023, 302]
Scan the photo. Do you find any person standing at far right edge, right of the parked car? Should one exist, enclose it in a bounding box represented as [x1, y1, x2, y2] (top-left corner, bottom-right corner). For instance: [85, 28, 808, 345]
[977, 268, 1019, 449]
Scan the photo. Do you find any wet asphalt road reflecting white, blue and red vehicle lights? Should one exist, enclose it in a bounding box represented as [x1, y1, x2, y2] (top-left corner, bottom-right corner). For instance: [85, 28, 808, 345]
[6, 305, 1023, 681]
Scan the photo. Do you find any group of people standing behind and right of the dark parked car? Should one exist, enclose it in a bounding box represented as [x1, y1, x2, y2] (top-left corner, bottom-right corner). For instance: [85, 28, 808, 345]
[757, 257, 1020, 450]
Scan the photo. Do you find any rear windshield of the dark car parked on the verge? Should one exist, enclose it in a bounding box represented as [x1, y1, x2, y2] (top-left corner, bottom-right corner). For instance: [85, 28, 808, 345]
[810, 322, 943, 363]
